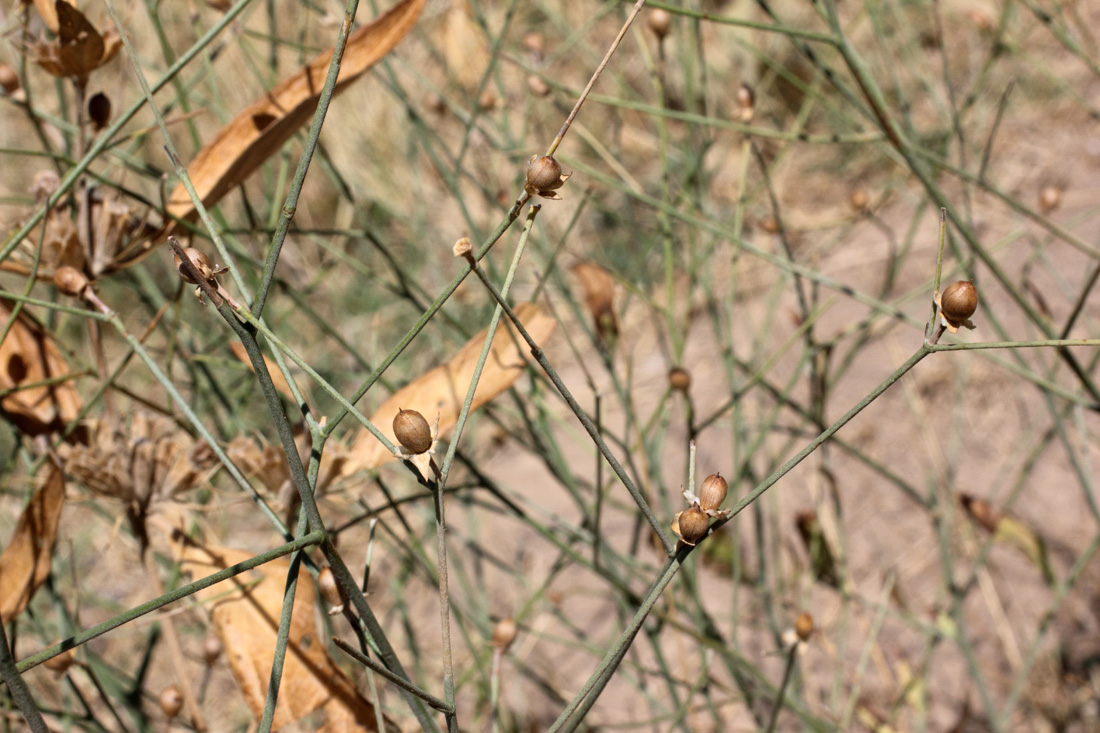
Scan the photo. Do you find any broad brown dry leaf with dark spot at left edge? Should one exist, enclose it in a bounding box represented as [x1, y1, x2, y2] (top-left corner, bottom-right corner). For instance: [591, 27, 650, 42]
[0, 302, 84, 436]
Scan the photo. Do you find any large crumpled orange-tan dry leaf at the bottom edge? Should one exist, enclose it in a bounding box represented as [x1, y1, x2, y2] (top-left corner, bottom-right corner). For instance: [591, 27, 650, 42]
[180, 546, 400, 733]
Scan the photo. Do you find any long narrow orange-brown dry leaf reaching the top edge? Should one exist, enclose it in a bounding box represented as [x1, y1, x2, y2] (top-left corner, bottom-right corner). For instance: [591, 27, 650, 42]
[161, 0, 425, 234]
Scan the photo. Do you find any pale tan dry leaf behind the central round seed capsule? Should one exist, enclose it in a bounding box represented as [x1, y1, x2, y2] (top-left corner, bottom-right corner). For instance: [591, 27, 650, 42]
[343, 303, 557, 475]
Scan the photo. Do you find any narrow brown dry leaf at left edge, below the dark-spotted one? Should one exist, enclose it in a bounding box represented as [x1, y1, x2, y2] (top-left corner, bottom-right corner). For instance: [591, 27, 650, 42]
[0, 461, 65, 623]
